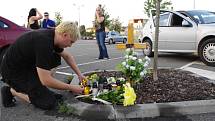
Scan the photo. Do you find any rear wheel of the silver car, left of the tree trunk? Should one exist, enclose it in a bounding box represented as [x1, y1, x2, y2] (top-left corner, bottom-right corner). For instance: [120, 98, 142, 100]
[143, 39, 154, 57]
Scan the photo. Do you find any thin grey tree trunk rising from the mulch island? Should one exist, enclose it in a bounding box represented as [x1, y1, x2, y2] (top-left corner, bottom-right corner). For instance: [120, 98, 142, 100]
[153, 0, 160, 81]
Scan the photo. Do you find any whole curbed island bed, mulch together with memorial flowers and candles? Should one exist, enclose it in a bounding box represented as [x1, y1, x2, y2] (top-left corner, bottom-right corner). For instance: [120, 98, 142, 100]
[73, 49, 215, 106]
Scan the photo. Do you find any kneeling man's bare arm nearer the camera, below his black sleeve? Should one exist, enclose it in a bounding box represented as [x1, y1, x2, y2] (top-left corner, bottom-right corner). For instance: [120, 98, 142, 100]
[37, 67, 83, 93]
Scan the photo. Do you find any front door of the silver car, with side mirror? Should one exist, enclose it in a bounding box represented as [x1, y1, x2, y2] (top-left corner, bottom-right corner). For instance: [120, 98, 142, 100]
[159, 12, 196, 52]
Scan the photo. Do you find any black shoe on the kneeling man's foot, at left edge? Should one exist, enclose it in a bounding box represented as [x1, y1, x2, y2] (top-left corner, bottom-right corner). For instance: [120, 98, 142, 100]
[1, 86, 16, 107]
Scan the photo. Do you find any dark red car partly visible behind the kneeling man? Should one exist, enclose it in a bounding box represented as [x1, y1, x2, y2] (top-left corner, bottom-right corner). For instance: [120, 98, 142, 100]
[0, 16, 30, 48]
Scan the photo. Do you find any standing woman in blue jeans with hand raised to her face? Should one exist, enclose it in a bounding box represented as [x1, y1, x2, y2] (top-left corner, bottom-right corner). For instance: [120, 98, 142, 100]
[95, 5, 109, 59]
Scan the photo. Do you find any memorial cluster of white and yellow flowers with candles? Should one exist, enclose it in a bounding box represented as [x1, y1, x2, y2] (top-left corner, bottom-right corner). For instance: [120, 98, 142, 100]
[74, 48, 150, 106]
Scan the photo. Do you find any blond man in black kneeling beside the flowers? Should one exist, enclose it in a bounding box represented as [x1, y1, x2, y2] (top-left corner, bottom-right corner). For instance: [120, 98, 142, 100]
[1, 22, 86, 109]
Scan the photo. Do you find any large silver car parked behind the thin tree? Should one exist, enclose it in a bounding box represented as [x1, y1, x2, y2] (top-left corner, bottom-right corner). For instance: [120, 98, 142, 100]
[141, 10, 215, 66]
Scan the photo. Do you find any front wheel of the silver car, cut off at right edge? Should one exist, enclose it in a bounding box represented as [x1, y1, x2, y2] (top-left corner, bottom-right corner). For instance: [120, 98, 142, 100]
[199, 38, 215, 66]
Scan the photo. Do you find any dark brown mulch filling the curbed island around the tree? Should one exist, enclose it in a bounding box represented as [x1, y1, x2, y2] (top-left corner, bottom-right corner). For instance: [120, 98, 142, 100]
[83, 69, 215, 104]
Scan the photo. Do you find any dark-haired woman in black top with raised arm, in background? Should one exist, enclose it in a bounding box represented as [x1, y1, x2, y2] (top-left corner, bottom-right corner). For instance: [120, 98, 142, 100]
[27, 8, 43, 29]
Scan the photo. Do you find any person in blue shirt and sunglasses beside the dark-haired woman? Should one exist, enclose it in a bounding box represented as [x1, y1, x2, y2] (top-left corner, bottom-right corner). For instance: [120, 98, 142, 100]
[42, 12, 55, 29]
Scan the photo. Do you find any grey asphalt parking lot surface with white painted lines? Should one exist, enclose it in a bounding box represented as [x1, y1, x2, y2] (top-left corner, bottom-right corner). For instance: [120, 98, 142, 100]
[0, 40, 215, 121]
